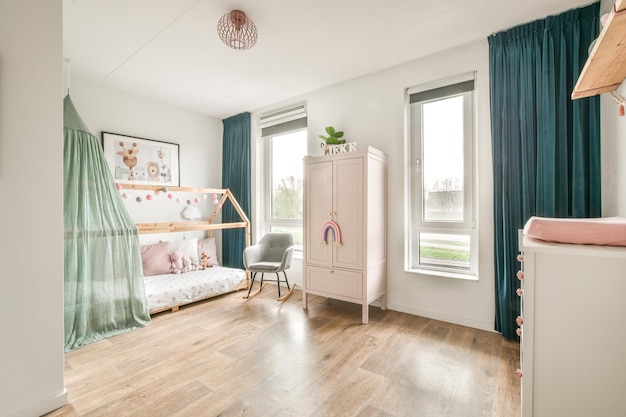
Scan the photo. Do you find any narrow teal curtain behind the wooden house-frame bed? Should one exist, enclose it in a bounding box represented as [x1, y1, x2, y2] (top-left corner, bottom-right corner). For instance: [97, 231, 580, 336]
[222, 112, 251, 269]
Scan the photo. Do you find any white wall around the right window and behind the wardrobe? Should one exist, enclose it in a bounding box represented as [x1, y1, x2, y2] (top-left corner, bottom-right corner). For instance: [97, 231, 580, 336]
[253, 40, 495, 330]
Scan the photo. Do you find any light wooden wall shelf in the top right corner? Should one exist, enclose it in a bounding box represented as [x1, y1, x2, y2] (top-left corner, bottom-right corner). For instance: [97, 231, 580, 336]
[572, 0, 626, 99]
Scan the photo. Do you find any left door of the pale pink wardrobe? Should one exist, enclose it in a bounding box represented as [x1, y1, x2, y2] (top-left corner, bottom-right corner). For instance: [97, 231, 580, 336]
[304, 161, 333, 266]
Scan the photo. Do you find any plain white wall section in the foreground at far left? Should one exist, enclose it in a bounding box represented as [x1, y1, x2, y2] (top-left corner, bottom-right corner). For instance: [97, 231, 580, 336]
[0, 0, 66, 417]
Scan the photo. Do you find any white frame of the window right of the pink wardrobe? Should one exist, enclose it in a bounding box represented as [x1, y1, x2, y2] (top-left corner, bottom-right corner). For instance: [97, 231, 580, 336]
[405, 73, 478, 279]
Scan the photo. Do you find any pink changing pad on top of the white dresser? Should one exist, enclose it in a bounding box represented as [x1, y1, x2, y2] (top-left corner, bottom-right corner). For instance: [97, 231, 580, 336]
[524, 217, 626, 246]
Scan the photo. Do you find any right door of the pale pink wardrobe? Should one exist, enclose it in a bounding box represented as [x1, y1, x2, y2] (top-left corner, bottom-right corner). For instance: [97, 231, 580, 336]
[332, 156, 365, 270]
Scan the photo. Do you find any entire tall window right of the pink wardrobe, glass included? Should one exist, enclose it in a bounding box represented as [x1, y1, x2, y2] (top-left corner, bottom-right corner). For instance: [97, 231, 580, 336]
[407, 75, 478, 278]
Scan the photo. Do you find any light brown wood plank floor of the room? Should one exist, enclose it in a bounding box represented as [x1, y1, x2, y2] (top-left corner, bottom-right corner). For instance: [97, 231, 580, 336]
[47, 286, 520, 417]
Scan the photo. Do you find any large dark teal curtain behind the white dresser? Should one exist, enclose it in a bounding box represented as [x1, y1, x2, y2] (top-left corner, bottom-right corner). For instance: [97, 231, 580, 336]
[489, 3, 601, 338]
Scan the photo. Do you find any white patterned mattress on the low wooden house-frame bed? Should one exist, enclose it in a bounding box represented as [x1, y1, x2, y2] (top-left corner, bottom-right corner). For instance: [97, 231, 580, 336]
[144, 266, 246, 313]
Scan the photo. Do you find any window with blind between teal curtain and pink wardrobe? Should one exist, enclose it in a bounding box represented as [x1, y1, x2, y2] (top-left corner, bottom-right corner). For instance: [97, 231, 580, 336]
[260, 106, 307, 250]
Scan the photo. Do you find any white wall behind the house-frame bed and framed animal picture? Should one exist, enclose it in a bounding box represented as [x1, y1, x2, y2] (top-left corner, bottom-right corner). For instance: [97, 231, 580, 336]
[69, 77, 223, 254]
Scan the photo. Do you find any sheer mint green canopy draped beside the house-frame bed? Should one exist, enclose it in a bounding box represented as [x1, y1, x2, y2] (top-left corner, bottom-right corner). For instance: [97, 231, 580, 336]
[63, 95, 150, 351]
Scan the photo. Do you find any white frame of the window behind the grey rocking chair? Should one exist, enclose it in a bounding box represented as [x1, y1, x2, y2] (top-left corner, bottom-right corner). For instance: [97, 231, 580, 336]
[259, 104, 307, 252]
